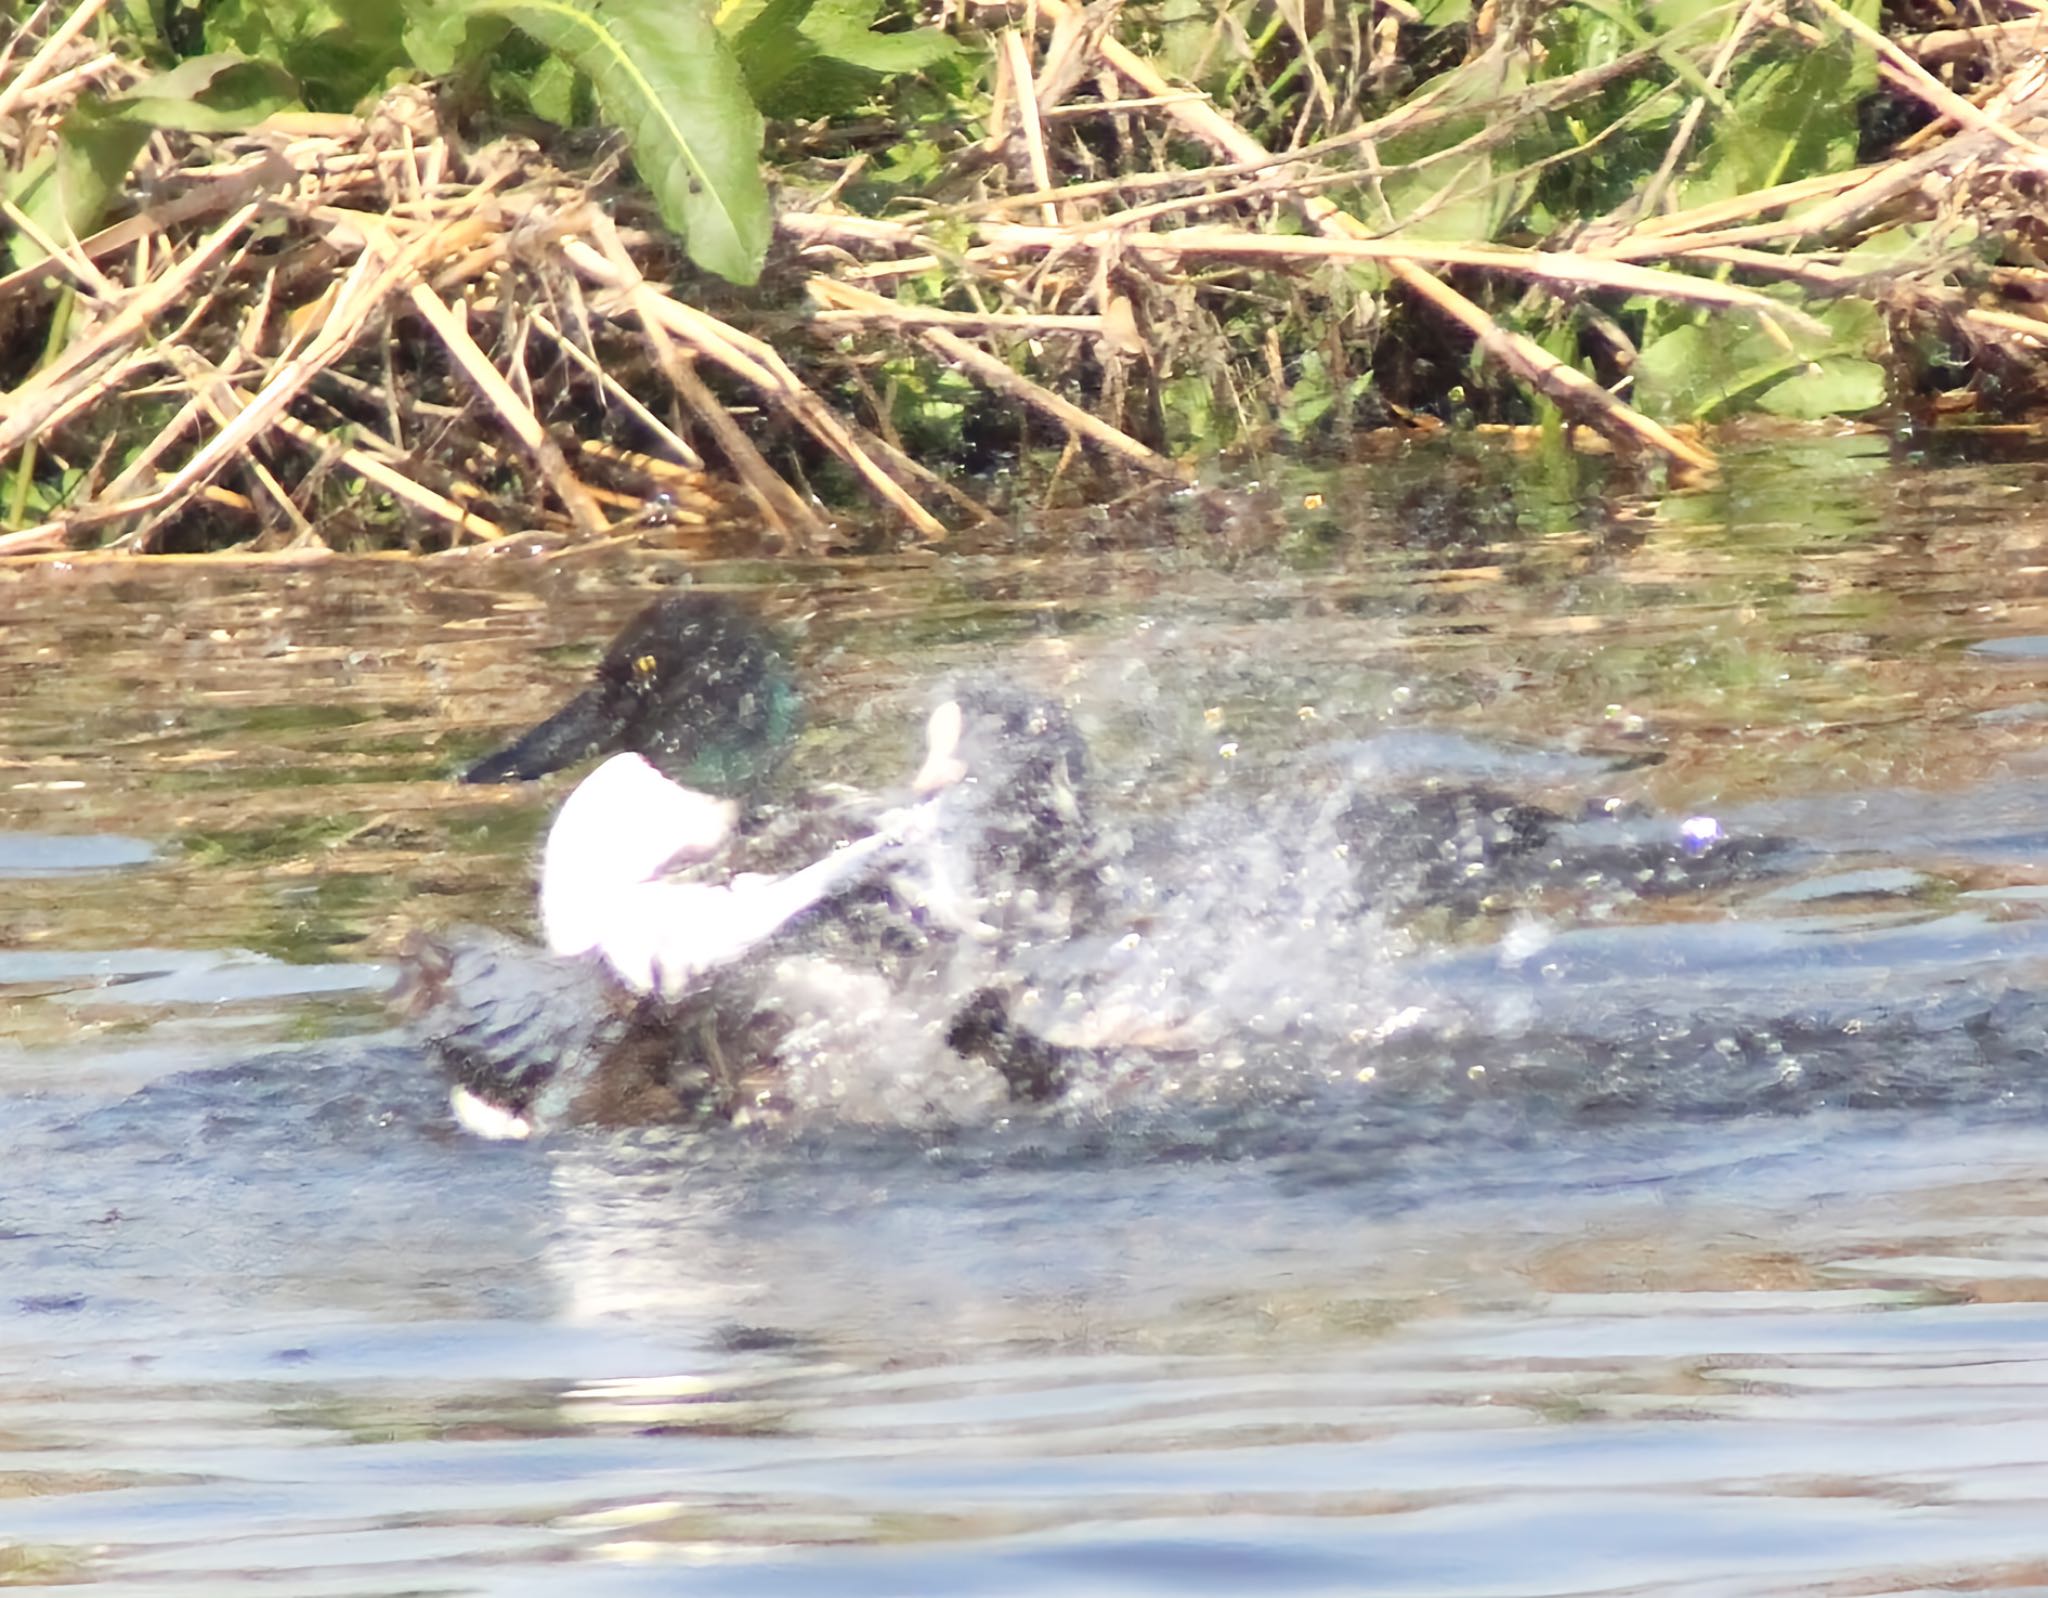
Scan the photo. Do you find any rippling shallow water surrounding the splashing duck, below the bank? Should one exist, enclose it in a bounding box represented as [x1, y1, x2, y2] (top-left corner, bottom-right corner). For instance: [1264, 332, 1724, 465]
[16, 438, 2048, 1596]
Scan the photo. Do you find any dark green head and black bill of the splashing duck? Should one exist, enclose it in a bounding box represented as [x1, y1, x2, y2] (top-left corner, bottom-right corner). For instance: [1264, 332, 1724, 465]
[463, 594, 803, 795]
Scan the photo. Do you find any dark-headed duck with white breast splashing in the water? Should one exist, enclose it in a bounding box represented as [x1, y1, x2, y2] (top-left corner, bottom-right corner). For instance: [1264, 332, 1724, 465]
[393, 594, 1092, 1139]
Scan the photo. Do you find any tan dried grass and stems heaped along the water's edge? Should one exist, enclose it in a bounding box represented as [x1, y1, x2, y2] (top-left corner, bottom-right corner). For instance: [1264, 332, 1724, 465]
[0, 0, 2048, 555]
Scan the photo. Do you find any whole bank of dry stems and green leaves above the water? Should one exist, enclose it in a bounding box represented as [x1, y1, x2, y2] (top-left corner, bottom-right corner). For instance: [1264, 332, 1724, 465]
[0, 0, 2048, 553]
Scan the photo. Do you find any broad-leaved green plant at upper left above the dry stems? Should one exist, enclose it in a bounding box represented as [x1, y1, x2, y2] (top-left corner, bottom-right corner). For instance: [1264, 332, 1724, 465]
[8, 0, 954, 283]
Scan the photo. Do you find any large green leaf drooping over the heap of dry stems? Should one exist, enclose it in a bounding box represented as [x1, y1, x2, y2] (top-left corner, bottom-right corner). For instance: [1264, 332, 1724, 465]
[408, 0, 774, 283]
